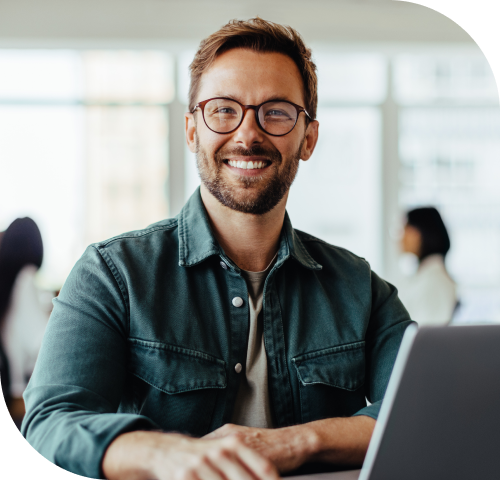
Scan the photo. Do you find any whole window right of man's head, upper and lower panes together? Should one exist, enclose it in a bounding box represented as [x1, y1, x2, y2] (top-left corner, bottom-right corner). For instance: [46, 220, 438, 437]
[288, 51, 387, 273]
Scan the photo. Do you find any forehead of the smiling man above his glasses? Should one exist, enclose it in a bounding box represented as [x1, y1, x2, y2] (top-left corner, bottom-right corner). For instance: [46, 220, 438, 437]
[196, 48, 304, 105]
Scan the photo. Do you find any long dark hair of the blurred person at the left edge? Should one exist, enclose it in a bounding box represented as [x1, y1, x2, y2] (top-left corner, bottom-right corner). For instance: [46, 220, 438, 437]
[0, 217, 43, 325]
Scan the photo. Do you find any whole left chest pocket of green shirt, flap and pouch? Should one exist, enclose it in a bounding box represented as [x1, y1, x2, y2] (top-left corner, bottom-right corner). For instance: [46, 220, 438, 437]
[129, 339, 227, 436]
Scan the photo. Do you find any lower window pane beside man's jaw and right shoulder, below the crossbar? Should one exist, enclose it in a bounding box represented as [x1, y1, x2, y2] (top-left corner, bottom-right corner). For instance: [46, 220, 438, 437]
[287, 107, 382, 272]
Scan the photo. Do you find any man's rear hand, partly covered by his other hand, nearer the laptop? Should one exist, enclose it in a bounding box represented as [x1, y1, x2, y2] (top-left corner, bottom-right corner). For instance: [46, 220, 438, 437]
[203, 423, 316, 472]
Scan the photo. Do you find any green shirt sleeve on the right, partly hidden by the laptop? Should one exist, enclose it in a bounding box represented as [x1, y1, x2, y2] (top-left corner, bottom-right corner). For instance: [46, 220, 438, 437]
[355, 272, 415, 420]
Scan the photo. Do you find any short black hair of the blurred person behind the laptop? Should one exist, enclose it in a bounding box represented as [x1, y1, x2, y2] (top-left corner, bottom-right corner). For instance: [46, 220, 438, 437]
[406, 207, 450, 261]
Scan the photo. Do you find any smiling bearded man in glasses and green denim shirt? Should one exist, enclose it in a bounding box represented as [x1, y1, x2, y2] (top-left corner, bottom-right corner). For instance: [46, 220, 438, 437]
[23, 18, 410, 480]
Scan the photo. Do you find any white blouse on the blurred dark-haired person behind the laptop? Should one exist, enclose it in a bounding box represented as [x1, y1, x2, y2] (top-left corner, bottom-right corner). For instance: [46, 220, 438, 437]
[399, 255, 457, 326]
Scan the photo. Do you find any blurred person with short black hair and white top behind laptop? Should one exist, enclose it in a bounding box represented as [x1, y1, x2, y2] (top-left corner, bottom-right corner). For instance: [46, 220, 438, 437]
[399, 207, 457, 325]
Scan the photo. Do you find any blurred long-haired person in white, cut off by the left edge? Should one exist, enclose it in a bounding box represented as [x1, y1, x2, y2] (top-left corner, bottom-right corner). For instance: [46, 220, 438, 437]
[0, 217, 48, 402]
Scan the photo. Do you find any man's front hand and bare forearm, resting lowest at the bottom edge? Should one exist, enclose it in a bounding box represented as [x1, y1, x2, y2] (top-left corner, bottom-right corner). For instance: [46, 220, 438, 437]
[103, 432, 279, 480]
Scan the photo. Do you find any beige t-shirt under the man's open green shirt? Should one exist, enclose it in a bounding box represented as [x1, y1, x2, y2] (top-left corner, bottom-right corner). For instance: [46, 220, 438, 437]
[231, 261, 274, 428]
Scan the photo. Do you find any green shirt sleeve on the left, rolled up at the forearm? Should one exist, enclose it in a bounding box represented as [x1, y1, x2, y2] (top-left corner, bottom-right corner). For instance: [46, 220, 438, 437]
[22, 246, 157, 479]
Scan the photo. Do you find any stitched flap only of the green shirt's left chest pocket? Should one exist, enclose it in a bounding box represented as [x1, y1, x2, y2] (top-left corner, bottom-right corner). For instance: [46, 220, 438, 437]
[129, 339, 226, 394]
